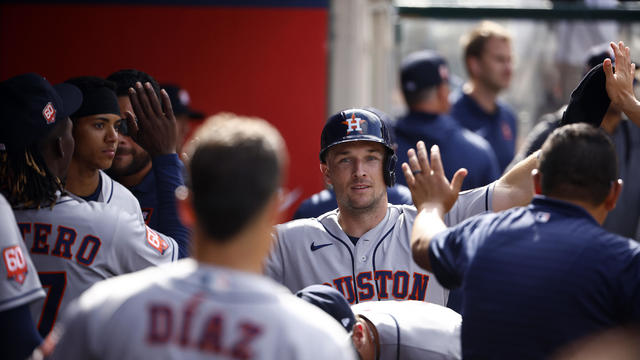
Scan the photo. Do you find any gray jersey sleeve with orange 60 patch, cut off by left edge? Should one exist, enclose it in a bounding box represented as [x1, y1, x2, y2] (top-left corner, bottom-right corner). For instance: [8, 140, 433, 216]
[0, 194, 45, 311]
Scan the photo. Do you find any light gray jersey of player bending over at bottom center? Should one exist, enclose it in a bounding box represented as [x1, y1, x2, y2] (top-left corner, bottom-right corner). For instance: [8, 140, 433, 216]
[351, 301, 462, 360]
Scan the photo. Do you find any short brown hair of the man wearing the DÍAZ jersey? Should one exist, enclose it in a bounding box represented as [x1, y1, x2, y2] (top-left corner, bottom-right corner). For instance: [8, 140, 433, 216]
[186, 113, 287, 242]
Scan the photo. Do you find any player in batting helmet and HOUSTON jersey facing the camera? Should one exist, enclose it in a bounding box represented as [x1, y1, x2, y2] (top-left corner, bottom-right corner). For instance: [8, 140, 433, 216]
[265, 109, 535, 305]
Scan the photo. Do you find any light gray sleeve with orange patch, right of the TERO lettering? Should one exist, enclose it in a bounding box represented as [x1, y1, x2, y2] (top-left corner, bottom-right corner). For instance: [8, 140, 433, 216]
[114, 208, 178, 274]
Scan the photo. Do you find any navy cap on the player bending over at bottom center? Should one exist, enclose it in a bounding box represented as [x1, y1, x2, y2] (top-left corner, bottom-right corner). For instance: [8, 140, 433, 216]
[296, 285, 356, 331]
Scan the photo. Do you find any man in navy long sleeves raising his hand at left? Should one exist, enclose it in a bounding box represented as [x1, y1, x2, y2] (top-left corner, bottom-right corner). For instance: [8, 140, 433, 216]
[107, 69, 189, 258]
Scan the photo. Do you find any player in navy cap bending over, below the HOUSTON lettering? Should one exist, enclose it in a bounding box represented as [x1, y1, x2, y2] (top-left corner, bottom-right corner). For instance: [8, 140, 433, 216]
[296, 285, 462, 360]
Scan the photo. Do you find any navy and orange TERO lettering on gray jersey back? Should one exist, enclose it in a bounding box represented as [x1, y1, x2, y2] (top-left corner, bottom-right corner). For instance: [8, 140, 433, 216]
[18, 223, 102, 266]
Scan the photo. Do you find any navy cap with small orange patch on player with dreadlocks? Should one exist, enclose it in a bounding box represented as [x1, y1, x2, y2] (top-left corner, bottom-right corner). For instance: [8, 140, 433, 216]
[0, 73, 82, 150]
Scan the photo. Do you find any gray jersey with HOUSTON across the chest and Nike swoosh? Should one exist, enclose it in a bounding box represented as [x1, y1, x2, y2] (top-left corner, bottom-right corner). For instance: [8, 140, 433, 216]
[265, 184, 493, 305]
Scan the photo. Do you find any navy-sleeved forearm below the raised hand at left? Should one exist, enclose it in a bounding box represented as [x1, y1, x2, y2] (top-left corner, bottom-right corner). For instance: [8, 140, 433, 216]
[153, 154, 189, 258]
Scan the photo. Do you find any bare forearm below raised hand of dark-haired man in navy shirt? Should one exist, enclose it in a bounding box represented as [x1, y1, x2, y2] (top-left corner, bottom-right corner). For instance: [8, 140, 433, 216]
[411, 205, 447, 271]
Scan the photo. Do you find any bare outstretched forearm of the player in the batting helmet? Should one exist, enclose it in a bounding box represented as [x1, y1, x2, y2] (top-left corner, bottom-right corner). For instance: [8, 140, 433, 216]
[491, 150, 540, 211]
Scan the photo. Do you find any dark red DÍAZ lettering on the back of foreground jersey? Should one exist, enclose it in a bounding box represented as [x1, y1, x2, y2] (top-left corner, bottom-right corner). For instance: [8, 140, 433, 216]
[146, 295, 262, 360]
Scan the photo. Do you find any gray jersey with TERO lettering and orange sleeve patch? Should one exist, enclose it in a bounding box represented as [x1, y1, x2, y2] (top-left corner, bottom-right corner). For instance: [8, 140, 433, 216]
[15, 196, 178, 334]
